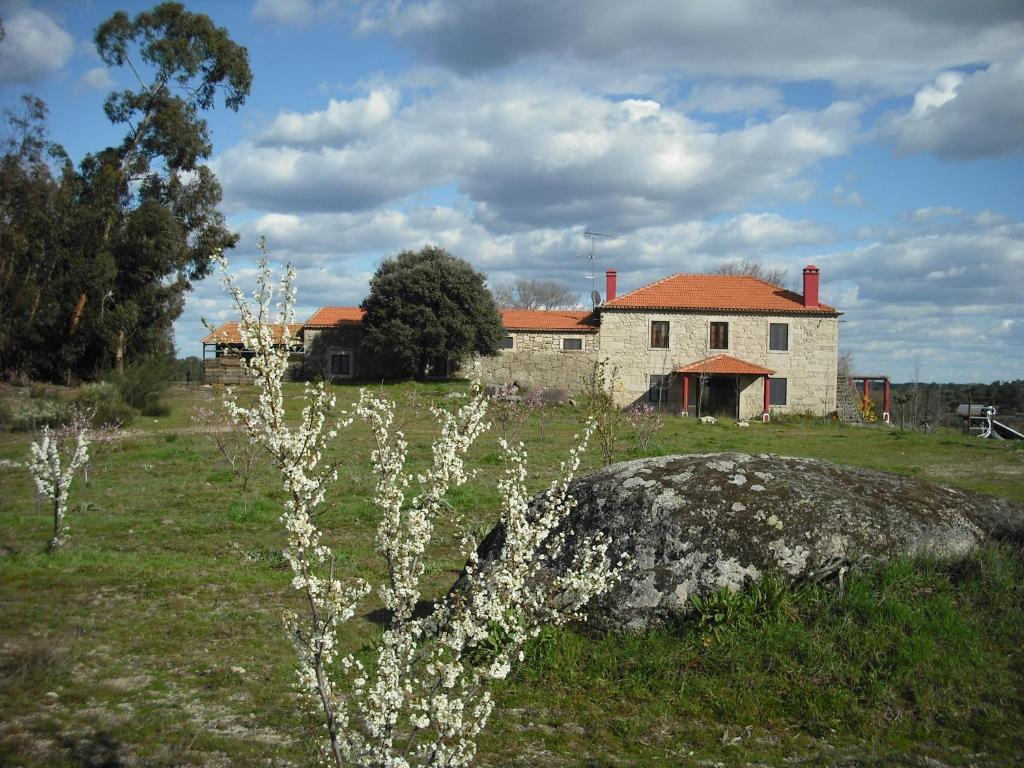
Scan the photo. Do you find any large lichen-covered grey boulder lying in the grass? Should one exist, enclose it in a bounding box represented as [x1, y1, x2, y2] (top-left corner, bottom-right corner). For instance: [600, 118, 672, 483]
[471, 454, 1024, 630]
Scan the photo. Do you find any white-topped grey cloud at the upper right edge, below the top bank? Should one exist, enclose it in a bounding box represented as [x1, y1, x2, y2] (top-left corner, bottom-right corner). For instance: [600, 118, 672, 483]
[883, 58, 1024, 160]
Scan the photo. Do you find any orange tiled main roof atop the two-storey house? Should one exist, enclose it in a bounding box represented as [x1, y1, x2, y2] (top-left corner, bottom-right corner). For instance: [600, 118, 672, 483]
[601, 274, 839, 314]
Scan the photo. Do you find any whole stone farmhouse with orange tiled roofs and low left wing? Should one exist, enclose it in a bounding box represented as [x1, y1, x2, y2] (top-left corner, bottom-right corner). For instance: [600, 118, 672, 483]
[204, 265, 840, 420]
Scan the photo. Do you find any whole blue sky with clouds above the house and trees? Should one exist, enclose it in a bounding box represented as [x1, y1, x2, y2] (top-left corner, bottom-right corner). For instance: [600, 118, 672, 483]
[0, 0, 1024, 381]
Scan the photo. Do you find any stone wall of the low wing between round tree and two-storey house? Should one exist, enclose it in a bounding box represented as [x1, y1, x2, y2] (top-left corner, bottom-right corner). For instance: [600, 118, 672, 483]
[473, 331, 600, 391]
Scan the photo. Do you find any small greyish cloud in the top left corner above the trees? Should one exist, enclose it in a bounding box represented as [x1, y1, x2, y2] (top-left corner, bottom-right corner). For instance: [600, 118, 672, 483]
[0, 6, 75, 83]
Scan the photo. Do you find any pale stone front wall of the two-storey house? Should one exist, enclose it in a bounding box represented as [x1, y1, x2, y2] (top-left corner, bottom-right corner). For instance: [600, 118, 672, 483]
[600, 310, 839, 418]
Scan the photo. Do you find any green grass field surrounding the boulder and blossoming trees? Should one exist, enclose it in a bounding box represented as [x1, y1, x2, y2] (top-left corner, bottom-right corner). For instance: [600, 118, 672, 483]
[0, 384, 1024, 766]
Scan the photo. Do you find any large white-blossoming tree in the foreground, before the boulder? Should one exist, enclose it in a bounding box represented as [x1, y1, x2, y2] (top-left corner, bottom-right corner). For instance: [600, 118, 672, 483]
[221, 247, 622, 768]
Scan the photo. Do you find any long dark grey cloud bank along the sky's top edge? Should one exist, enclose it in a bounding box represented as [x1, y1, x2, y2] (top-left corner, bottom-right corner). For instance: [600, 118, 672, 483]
[360, 0, 1024, 90]
